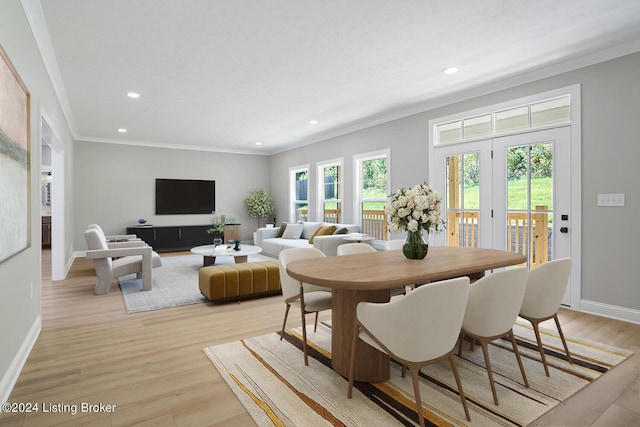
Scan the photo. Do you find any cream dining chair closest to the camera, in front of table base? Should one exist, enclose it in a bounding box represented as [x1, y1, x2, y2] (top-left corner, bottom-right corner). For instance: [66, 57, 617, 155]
[347, 277, 471, 426]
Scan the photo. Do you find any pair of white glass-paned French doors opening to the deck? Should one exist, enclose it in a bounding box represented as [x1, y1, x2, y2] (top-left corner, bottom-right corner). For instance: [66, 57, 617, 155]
[431, 126, 572, 305]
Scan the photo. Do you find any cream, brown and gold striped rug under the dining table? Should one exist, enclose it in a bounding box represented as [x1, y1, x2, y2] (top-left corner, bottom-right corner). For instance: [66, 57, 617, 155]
[204, 323, 633, 426]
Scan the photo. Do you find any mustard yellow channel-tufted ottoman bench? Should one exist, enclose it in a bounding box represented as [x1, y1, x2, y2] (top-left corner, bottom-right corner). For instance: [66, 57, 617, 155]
[198, 260, 282, 302]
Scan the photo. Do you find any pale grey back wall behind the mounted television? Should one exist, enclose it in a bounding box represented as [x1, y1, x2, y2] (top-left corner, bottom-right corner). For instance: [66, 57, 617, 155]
[73, 142, 269, 250]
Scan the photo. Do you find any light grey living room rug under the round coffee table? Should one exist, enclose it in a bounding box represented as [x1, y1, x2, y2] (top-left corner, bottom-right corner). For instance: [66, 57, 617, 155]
[118, 254, 273, 314]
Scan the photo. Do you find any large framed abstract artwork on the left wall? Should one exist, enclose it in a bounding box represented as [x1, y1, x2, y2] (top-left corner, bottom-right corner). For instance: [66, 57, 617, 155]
[0, 46, 31, 263]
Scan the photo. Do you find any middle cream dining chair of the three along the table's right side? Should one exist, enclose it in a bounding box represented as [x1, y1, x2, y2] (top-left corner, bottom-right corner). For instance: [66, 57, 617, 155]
[458, 267, 529, 405]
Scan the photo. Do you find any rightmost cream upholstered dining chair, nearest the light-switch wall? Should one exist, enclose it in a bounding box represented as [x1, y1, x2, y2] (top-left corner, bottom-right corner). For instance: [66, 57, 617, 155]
[520, 258, 573, 376]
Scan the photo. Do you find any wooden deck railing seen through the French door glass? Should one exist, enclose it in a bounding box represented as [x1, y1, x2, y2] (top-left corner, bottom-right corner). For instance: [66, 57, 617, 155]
[447, 206, 549, 268]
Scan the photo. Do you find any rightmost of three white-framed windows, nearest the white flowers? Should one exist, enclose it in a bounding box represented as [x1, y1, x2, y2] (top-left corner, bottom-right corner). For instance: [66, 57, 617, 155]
[354, 150, 391, 240]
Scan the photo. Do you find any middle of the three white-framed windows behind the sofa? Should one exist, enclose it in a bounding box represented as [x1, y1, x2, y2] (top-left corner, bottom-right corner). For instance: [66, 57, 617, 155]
[318, 159, 342, 224]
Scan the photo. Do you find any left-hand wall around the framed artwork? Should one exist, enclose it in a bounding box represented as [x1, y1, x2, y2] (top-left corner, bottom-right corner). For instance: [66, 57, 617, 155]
[0, 0, 73, 402]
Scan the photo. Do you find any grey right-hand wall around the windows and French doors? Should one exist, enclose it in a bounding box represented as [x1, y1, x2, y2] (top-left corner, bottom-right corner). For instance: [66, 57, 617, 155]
[270, 53, 640, 322]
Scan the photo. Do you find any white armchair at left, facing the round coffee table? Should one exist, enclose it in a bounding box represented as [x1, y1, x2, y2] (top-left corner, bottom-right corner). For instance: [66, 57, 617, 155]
[84, 224, 162, 295]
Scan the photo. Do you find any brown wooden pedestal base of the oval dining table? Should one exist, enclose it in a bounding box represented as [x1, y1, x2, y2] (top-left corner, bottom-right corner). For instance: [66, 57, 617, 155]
[331, 289, 390, 382]
